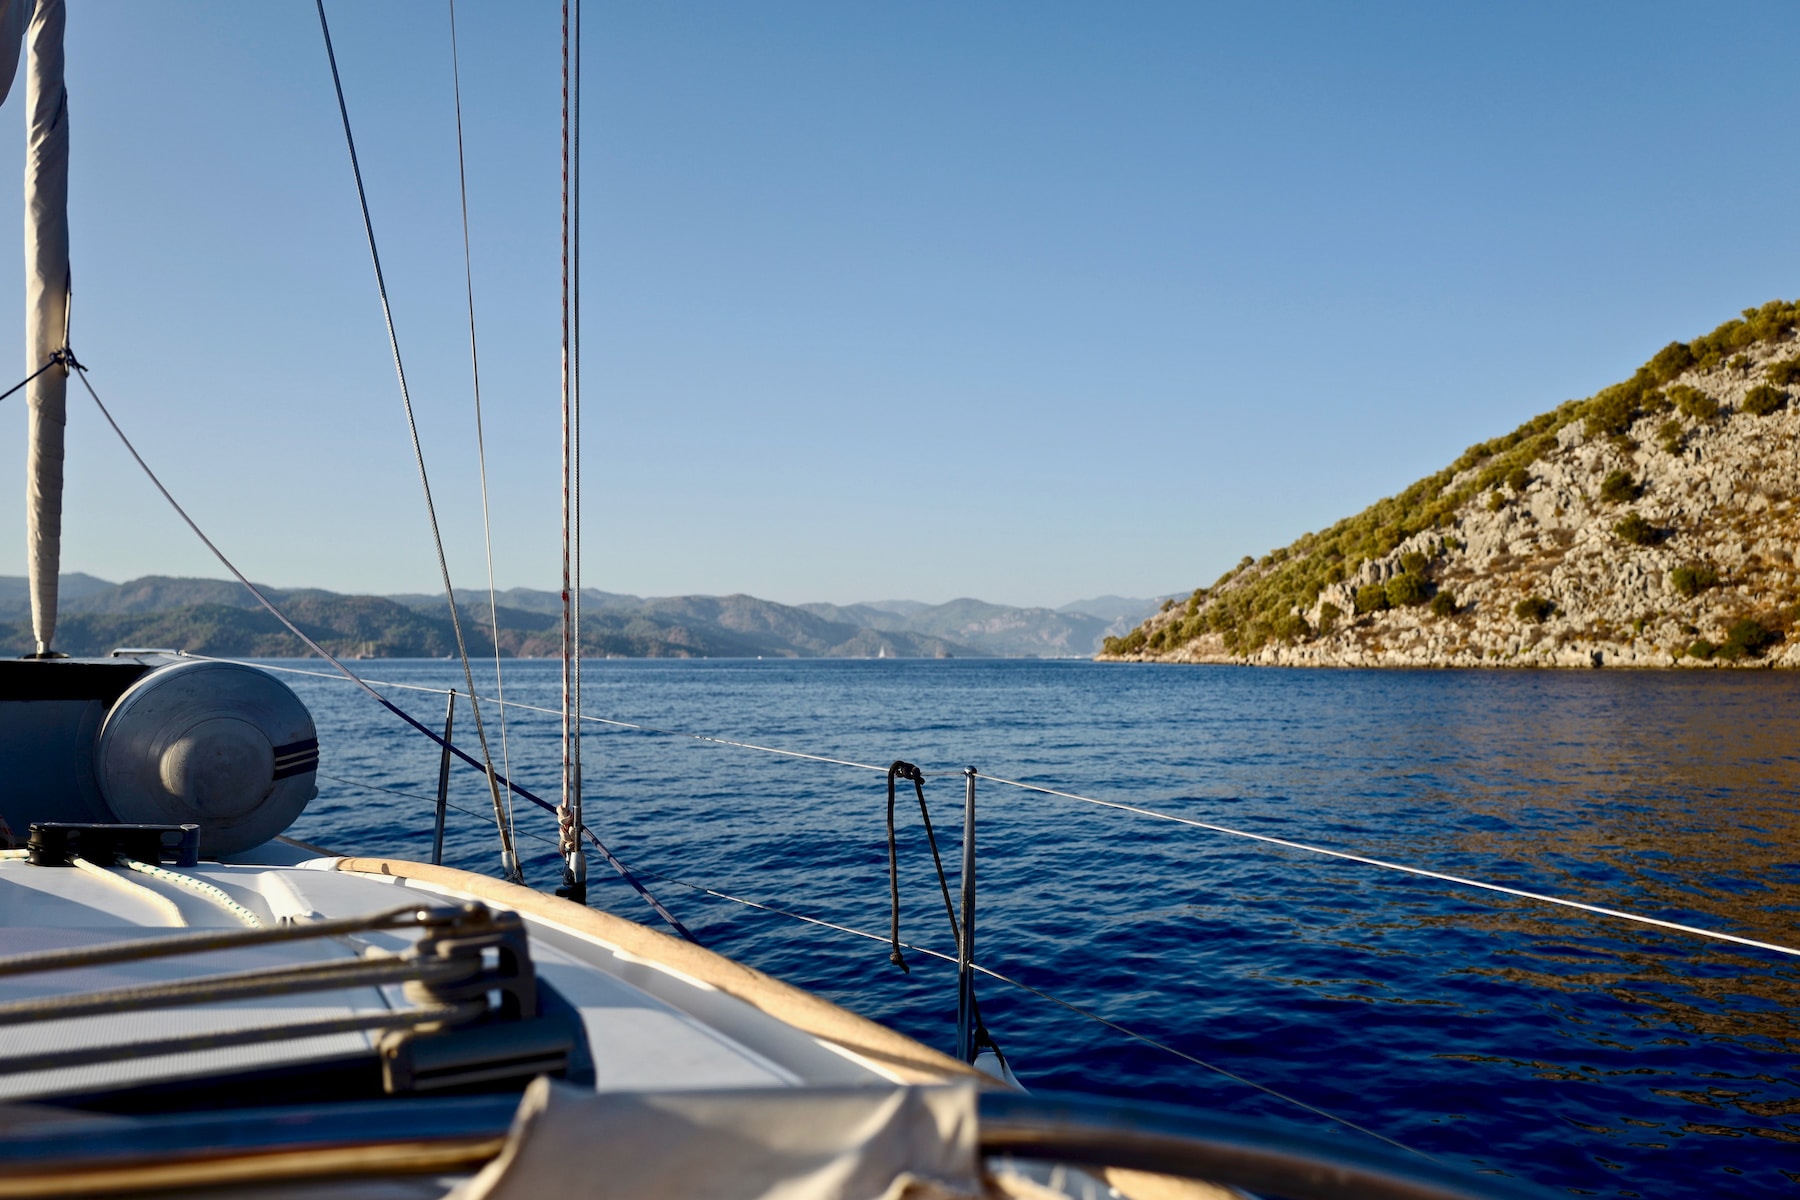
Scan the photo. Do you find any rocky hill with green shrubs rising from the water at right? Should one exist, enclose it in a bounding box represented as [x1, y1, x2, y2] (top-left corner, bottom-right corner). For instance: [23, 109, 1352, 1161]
[1102, 300, 1800, 667]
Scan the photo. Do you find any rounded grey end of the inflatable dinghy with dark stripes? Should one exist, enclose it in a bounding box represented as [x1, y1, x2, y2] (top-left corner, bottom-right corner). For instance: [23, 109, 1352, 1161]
[94, 662, 319, 858]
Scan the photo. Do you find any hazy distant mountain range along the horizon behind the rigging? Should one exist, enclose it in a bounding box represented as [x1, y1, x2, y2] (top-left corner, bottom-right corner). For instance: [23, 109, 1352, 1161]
[0, 572, 1159, 658]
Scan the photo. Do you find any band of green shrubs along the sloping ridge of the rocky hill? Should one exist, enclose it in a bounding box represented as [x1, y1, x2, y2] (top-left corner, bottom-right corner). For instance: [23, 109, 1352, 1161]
[1107, 300, 1800, 655]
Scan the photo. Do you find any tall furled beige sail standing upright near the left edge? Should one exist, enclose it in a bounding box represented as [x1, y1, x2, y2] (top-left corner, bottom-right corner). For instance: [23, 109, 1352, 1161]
[13, 0, 68, 658]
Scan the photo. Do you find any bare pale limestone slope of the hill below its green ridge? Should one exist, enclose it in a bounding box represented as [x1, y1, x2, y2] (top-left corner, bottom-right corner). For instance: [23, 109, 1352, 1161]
[1103, 335, 1800, 667]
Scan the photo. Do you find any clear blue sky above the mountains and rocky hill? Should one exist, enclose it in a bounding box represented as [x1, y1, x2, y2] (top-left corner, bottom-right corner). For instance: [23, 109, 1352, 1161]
[0, 0, 1800, 604]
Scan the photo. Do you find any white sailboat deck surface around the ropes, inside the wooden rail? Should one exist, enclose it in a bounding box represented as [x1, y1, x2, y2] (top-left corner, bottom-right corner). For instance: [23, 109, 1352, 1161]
[0, 858, 900, 1101]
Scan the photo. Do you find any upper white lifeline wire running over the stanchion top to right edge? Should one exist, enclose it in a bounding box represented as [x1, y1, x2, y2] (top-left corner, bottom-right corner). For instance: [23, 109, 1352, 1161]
[171, 655, 1800, 957]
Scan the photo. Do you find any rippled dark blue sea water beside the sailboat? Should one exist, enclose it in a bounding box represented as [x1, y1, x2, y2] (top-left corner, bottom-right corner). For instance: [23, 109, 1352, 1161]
[286, 660, 1800, 1196]
